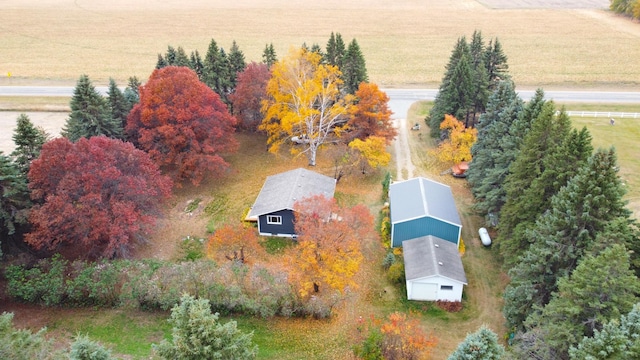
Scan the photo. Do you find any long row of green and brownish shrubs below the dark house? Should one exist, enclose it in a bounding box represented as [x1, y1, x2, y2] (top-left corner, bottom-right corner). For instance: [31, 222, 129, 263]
[5, 256, 336, 318]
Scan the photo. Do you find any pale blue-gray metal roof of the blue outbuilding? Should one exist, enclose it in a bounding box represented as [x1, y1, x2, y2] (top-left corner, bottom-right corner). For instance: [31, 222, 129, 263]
[389, 177, 462, 225]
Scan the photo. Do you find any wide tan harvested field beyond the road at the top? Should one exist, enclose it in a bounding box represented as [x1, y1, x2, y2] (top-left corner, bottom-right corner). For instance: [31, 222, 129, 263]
[0, 0, 640, 89]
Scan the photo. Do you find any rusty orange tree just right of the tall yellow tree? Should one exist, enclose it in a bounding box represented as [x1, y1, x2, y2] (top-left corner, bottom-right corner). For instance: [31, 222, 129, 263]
[347, 82, 397, 145]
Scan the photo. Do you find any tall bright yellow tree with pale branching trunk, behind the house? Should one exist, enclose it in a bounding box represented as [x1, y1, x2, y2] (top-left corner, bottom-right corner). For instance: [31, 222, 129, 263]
[260, 48, 353, 166]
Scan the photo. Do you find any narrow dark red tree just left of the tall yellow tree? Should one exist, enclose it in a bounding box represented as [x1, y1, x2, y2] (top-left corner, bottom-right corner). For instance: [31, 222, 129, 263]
[229, 62, 271, 131]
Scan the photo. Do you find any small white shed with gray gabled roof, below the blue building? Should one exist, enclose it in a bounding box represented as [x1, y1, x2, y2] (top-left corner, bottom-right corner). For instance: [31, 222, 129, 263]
[402, 235, 467, 301]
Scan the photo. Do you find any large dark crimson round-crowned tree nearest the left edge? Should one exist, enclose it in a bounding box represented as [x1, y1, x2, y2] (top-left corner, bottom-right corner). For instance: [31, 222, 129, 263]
[25, 136, 172, 258]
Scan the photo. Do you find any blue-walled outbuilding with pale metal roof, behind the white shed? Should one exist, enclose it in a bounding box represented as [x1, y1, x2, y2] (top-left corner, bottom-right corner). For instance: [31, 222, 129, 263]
[389, 177, 462, 247]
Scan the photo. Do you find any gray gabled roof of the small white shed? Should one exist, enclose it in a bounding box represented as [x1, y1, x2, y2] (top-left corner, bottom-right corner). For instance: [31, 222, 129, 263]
[402, 235, 467, 285]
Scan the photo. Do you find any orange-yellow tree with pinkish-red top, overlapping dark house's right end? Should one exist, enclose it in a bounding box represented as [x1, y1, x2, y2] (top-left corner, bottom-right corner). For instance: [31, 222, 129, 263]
[287, 195, 376, 298]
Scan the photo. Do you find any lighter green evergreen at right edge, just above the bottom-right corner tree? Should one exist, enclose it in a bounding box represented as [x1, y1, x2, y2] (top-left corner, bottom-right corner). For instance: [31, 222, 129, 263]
[526, 244, 640, 358]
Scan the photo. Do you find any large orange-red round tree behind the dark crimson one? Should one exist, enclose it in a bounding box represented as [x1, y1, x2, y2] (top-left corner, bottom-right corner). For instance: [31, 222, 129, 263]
[126, 66, 238, 185]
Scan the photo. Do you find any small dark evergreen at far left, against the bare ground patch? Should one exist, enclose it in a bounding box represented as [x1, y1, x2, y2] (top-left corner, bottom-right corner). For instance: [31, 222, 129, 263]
[11, 114, 48, 174]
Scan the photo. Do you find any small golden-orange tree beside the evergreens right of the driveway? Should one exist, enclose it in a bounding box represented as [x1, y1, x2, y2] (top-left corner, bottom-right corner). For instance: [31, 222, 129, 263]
[431, 114, 478, 164]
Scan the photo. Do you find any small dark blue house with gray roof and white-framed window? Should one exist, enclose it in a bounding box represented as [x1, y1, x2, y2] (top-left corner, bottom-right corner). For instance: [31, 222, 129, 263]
[247, 168, 336, 237]
